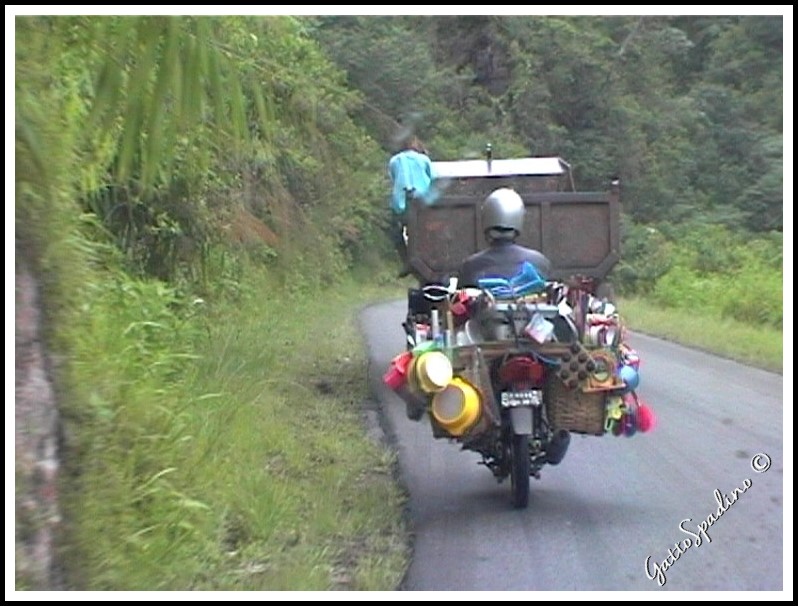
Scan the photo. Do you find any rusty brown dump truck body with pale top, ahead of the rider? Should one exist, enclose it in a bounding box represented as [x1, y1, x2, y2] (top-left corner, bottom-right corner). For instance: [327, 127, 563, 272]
[407, 152, 620, 284]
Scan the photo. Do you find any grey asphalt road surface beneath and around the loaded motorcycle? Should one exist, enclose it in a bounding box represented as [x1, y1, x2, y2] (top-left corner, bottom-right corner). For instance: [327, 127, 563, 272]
[361, 301, 792, 597]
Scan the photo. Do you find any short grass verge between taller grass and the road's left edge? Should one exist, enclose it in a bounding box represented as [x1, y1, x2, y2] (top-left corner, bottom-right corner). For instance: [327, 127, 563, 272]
[184, 278, 407, 590]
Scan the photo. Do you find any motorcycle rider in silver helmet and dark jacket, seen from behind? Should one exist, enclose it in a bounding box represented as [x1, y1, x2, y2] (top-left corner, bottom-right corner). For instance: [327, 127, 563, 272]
[458, 187, 551, 287]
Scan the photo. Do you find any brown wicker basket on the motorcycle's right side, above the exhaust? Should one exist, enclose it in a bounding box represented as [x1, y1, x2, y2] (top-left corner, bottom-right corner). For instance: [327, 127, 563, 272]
[545, 376, 606, 436]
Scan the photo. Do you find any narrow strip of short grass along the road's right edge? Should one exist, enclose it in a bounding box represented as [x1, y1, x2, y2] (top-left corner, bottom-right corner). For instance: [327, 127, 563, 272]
[618, 298, 784, 373]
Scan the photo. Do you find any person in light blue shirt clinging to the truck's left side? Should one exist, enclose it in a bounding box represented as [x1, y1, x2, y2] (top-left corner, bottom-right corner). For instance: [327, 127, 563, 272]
[388, 136, 434, 278]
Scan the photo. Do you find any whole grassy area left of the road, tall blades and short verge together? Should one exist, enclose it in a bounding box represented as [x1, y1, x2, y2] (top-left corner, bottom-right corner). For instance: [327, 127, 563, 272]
[65, 272, 409, 591]
